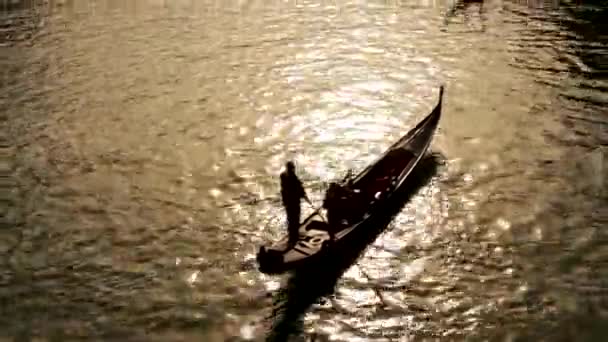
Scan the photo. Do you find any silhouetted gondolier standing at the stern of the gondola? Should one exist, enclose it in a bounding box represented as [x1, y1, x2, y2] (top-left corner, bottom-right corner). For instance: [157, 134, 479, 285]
[281, 161, 311, 245]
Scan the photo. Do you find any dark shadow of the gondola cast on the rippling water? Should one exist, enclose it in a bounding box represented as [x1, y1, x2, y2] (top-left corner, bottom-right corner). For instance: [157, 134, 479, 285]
[267, 154, 443, 341]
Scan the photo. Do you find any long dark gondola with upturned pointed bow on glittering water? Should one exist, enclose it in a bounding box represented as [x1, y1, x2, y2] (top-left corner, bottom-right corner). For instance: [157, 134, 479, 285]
[257, 86, 443, 274]
